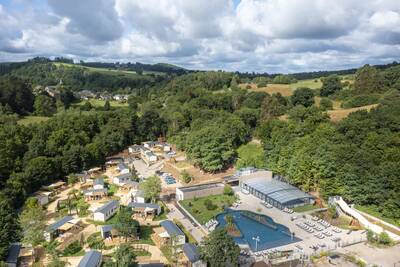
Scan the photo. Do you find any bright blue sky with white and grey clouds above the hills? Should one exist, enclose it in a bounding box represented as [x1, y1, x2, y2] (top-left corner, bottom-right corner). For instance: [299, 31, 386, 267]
[0, 0, 400, 73]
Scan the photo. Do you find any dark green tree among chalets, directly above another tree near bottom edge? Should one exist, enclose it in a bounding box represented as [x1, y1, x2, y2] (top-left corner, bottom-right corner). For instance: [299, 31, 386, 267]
[114, 208, 139, 242]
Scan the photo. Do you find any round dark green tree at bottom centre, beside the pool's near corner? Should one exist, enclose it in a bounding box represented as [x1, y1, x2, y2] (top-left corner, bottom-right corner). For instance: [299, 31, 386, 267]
[200, 229, 240, 267]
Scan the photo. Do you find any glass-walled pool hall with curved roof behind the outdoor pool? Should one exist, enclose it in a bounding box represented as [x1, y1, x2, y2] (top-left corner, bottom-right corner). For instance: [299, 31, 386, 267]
[240, 171, 314, 209]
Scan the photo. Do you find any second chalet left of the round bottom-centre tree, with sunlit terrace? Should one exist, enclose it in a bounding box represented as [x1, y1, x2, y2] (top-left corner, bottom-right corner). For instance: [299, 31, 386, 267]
[153, 220, 186, 247]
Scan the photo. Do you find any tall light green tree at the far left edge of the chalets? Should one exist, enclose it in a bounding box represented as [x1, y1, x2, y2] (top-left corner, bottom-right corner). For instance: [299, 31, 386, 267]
[19, 198, 46, 255]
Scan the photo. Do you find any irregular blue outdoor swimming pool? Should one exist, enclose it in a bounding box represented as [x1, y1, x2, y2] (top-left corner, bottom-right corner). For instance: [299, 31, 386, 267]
[216, 210, 301, 252]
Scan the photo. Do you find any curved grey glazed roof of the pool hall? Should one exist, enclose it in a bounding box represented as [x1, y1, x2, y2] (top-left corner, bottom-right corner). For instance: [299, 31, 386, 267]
[243, 178, 314, 204]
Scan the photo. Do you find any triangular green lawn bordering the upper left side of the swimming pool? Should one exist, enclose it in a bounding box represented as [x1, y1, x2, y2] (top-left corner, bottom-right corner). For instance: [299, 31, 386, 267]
[180, 195, 236, 224]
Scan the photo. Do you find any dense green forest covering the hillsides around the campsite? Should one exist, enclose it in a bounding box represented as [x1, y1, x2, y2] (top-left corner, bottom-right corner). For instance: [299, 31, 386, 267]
[0, 60, 400, 257]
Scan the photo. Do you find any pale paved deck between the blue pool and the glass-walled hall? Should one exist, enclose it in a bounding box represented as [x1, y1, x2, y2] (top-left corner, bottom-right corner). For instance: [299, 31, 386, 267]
[234, 190, 366, 255]
